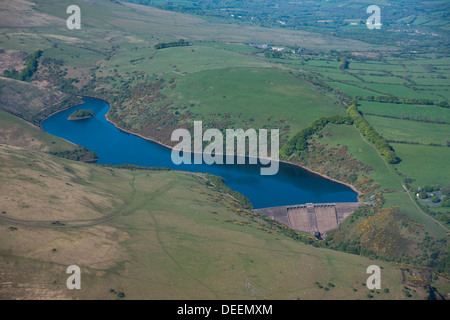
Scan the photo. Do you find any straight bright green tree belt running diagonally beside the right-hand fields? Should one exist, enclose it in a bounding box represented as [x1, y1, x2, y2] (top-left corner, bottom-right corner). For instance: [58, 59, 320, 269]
[347, 104, 400, 164]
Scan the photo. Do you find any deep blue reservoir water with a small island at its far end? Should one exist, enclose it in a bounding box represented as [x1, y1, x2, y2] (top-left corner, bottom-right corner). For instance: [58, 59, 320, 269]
[42, 98, 357, 208]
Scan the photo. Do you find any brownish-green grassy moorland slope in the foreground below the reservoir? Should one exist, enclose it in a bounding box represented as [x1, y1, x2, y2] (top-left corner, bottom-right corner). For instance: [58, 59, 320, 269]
[0, 145, 440, 299]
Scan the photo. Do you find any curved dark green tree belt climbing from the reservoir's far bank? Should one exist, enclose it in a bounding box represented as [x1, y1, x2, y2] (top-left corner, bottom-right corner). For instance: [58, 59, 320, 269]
[280, 116, 353, 158]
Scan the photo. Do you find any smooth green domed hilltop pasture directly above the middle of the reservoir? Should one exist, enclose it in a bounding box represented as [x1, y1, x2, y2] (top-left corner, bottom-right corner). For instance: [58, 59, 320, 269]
[163, 67, 345, 136]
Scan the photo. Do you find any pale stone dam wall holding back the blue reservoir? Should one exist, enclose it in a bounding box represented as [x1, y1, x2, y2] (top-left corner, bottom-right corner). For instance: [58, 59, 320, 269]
[255, 202, 366, 239]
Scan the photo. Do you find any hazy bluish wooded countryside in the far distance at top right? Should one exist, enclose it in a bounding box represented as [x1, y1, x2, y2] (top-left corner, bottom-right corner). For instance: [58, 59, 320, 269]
[129, 0, 450, 50]
